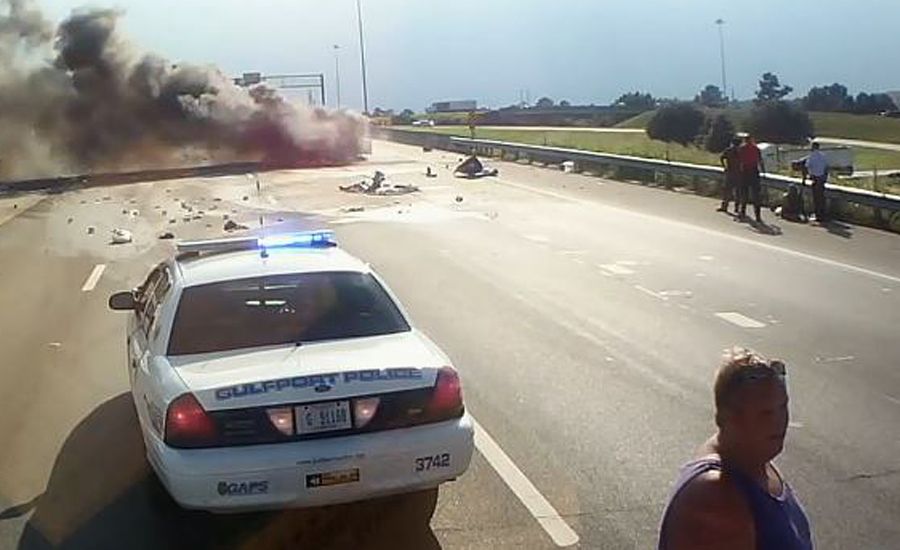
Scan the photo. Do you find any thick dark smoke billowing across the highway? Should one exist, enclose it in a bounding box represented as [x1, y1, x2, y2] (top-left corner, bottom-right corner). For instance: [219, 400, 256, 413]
[0, 0, 365, 178]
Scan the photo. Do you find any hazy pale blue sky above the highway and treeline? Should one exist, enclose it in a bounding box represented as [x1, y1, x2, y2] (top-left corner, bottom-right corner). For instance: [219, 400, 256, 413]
[45, 0, 900, 110]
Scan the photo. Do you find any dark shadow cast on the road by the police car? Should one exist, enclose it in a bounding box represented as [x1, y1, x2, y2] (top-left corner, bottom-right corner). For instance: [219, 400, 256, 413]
[19, 393, 440, 550]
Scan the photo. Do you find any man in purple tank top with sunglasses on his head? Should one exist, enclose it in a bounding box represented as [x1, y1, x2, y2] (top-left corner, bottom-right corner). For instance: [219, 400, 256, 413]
[658, 348, 813, 550]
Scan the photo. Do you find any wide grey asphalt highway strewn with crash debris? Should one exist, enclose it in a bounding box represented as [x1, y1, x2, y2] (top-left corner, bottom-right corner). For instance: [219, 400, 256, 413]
[0, 142, 900, 549]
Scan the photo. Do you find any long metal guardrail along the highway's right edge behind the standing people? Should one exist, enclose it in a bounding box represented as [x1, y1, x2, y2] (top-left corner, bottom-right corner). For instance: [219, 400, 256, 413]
[375, 128, 900, 232]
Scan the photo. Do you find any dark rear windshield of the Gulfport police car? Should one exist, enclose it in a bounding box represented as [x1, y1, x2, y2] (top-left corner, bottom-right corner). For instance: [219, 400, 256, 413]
[169, 272, 410, 355]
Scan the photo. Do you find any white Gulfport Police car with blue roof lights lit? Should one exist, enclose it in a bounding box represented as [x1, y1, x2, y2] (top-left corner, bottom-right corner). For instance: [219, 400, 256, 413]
[109, 232, 473, 511]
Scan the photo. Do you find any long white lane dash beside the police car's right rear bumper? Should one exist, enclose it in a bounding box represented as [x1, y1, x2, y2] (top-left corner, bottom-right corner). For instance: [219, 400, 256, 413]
[472, 418, 578, 547]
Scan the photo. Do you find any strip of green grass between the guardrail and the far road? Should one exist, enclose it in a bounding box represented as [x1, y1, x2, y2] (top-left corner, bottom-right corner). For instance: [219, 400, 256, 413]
[410, 126, 900, 194]
